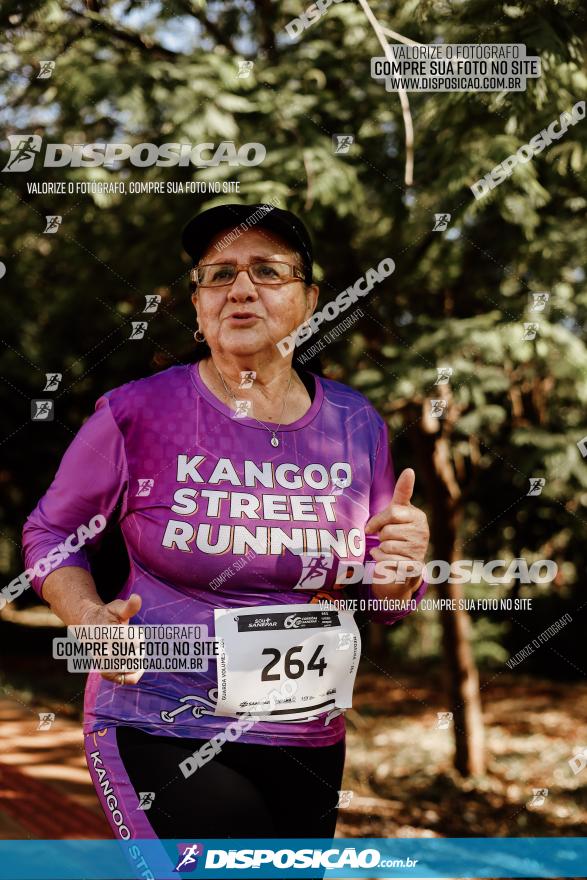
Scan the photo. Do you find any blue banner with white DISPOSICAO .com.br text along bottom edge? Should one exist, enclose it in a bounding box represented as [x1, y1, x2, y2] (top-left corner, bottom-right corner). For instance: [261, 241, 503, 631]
[0, 837, 587, 880]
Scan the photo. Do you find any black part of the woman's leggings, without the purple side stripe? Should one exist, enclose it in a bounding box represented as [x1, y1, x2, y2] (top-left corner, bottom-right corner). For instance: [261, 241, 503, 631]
[116, 727, 345, 840]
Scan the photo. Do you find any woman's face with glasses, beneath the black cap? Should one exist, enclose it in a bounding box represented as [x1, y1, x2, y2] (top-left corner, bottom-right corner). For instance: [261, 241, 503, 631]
[192, 229, 318, 357]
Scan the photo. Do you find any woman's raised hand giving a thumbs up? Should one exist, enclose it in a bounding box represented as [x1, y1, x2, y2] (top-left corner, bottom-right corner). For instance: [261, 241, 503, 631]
[365, 468, 430, 599]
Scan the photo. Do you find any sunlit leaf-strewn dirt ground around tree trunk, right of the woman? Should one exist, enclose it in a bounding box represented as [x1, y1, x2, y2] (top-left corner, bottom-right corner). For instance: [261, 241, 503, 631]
[338, 673, 587, 837]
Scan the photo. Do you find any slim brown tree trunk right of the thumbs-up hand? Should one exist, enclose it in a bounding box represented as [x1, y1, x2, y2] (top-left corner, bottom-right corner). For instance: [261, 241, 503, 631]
[414, 412, 485, 776]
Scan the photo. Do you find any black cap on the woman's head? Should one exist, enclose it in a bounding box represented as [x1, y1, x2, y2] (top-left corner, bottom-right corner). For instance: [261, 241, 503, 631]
[181, 204, 313, 284]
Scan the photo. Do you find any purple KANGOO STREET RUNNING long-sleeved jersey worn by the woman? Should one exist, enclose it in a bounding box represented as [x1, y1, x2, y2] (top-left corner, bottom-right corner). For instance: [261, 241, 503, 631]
[23, 364, 426, 746]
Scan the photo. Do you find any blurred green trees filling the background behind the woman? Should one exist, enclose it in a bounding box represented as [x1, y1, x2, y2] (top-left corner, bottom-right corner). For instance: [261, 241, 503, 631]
[0, 0, 587, 774]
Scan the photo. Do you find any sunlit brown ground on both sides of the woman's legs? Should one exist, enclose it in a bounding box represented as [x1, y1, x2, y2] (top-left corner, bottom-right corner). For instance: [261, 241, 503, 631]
[0, 667, 587, 838]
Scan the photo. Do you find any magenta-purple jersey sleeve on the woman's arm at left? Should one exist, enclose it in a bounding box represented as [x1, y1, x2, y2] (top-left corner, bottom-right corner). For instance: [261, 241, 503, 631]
[21, 396, 128, 598]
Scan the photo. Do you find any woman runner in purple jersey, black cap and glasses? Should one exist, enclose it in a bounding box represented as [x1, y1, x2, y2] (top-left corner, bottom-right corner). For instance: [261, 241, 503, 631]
[24, 204, 428, 840]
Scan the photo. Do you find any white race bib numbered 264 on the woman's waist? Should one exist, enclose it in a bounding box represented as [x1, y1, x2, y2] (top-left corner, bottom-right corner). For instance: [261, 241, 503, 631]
[214, 605, 361, 722]
